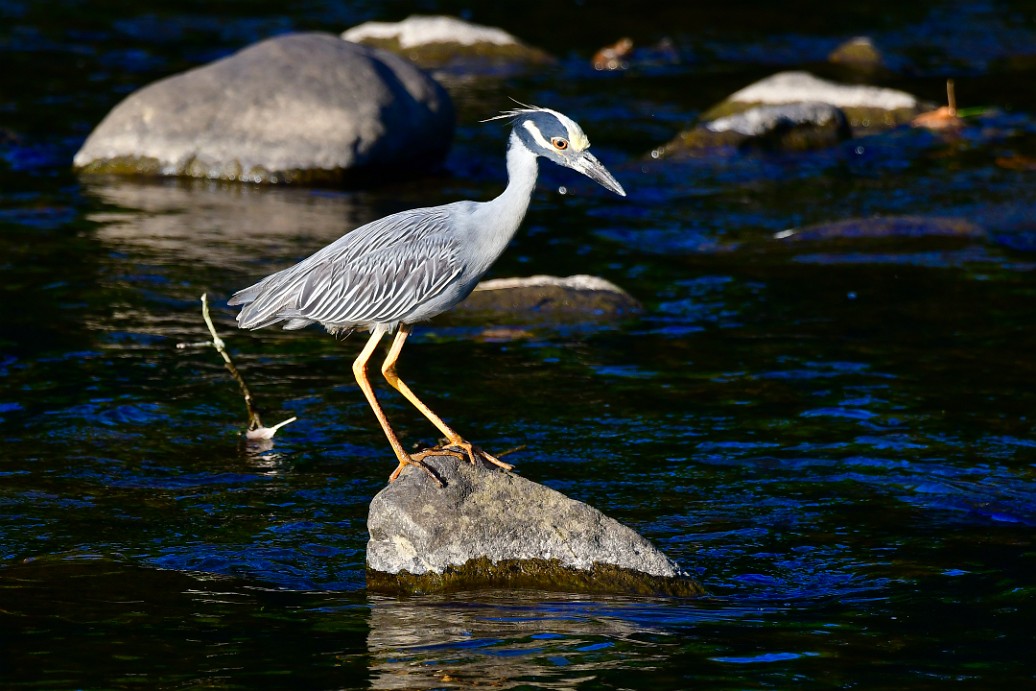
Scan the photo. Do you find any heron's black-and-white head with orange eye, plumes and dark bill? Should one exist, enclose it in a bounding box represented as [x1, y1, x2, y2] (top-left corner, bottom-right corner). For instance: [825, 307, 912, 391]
[486, 106, 626, 197]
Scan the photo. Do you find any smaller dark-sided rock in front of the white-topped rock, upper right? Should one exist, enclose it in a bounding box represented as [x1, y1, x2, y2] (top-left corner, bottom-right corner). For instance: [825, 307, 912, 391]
[657, 103, 853, 157]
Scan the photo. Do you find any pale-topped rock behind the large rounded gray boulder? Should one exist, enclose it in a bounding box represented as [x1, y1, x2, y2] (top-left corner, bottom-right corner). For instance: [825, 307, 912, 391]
[342, 15, 553, 74]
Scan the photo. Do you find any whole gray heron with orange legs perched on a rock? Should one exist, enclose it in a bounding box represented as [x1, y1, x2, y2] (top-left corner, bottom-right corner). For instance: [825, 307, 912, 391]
[230, 107, 626, 480]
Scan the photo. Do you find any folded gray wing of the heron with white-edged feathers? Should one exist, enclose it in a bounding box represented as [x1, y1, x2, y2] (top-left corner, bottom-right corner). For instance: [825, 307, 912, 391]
[230, 207, 461, 328]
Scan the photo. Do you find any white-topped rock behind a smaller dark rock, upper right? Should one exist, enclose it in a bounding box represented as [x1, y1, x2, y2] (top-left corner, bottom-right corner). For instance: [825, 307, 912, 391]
[702, 71, 928, 131]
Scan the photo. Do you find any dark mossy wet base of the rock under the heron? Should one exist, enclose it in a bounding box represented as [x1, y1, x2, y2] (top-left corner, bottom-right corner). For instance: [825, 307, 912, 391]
[367, 557, 704, 598]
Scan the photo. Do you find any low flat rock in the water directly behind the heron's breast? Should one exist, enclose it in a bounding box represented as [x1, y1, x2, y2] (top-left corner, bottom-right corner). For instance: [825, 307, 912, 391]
[451, 275, 641, 323]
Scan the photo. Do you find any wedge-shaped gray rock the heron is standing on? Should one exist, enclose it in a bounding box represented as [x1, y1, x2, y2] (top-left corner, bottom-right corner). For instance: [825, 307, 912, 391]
[367, 457, 701, 596]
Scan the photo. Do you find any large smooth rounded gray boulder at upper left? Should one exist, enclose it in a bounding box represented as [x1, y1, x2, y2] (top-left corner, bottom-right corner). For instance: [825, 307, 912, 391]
[74, 33, 454, 183]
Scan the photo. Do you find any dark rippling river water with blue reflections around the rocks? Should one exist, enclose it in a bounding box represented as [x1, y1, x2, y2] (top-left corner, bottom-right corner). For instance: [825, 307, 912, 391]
[0, 1, 1036, 689]
